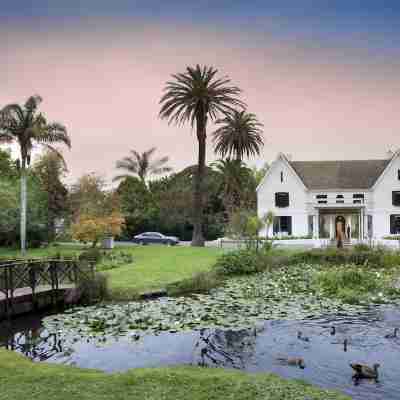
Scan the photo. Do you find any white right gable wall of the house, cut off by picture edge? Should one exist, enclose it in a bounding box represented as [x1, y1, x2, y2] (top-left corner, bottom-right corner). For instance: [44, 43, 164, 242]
[369, 156, 400, 238]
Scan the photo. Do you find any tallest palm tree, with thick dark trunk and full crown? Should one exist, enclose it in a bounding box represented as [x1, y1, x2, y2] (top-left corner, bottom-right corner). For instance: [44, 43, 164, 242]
[160, 65, 244, 246]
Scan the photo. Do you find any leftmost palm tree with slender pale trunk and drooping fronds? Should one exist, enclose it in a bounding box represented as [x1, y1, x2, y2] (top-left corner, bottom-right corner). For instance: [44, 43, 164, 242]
[0, 96, 71, 254]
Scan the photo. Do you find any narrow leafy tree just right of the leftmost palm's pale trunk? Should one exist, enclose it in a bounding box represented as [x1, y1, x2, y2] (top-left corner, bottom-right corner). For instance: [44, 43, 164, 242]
[33, 151, 68, 240]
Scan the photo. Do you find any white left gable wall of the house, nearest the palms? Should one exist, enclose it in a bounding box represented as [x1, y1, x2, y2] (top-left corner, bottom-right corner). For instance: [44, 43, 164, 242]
[257, 157, 308, 236]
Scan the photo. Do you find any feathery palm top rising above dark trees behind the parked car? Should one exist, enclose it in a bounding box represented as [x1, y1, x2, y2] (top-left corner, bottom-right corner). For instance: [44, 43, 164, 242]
[113, 147, 172, 184]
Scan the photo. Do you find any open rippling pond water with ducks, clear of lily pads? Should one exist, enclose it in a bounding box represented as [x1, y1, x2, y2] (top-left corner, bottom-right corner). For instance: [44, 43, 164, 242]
[0, 306, 400, 400]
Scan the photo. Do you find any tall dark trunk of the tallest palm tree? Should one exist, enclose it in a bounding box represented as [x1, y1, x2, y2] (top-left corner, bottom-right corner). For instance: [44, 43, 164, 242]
[192, 116, 206, 247]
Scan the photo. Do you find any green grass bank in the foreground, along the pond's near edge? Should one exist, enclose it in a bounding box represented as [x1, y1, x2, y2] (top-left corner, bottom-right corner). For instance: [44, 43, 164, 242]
[0, 350, 349, 400]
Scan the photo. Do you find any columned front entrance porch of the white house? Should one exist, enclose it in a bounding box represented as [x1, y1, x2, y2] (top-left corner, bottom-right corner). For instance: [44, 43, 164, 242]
[315, 207, 365, 241]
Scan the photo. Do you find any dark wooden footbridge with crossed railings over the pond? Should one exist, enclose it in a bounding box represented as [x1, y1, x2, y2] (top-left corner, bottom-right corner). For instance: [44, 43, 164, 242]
[0, 259, 94, 320]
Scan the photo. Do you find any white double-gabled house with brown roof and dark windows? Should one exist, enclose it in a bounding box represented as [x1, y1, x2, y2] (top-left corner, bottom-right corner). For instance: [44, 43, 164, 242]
[257, 152, 400, 241]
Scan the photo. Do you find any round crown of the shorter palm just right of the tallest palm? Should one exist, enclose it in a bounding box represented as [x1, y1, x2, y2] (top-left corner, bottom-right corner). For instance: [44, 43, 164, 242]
[213, 110, 264, 160]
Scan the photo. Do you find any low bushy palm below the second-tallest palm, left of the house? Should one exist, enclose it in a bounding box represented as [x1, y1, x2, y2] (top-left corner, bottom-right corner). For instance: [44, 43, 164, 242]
[212, 159, 254, 219]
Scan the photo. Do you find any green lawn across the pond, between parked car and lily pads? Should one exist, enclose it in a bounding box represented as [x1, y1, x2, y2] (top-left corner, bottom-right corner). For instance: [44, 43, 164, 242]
[107, 246, 223, 298]
